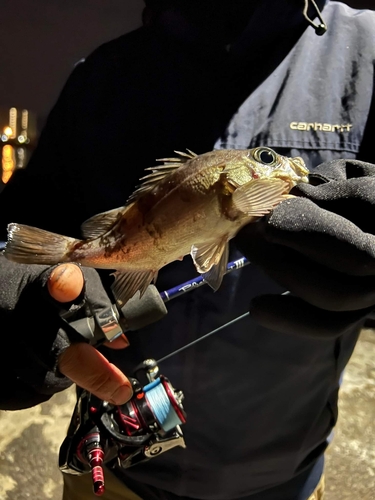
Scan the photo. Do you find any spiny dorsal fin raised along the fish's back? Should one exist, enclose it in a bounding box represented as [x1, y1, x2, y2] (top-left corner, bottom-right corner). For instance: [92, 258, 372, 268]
[127, 149, 197, 204]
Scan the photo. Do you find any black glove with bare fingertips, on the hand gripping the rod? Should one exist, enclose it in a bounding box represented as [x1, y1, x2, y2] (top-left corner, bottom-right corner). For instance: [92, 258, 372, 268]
[0, 255, 119, 410]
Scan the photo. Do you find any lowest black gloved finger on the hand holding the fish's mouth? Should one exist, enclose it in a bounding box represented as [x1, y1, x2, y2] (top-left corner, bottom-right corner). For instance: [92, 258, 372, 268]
[250, 294, 371, 339]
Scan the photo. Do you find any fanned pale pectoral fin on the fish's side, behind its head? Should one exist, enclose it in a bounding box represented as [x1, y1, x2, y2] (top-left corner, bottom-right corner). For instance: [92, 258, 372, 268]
[232, 179, 288, 217]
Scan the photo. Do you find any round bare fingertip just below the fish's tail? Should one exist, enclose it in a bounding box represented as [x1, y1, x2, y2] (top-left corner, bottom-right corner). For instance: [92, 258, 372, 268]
[47, 263, 85, 303]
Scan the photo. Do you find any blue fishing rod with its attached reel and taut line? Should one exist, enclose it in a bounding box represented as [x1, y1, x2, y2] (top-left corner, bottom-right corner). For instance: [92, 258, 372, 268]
[59, 257, 250, 496]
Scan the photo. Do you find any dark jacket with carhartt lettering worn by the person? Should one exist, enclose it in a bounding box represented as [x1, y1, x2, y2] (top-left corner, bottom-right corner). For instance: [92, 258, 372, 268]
[0, 0, 375, 500]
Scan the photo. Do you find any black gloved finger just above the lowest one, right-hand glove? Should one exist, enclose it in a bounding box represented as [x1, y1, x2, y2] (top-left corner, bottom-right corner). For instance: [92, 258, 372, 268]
[237, 228, 375, 311]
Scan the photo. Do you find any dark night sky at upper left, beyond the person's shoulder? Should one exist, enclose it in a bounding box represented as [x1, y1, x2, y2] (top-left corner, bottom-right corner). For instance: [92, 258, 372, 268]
[0, 0, 375, 123]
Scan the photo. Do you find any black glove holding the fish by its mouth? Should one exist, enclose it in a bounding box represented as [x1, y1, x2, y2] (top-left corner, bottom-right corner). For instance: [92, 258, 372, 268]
[235, 160, 375, 337]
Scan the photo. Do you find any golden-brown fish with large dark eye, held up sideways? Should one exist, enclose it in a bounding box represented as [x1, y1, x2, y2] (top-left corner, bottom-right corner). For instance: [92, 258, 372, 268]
[4, 147, 309, 307]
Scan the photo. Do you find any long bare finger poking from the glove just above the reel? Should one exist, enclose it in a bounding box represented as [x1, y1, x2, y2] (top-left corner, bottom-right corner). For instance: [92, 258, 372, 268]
[58, 343, 133, 405]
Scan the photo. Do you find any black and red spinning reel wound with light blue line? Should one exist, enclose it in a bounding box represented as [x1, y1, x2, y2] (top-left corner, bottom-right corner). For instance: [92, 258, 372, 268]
[59, 359, 186, 496]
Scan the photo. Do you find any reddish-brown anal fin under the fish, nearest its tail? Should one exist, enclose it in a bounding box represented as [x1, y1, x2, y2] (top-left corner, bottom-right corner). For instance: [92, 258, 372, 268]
[111, 271, 157, 308]
